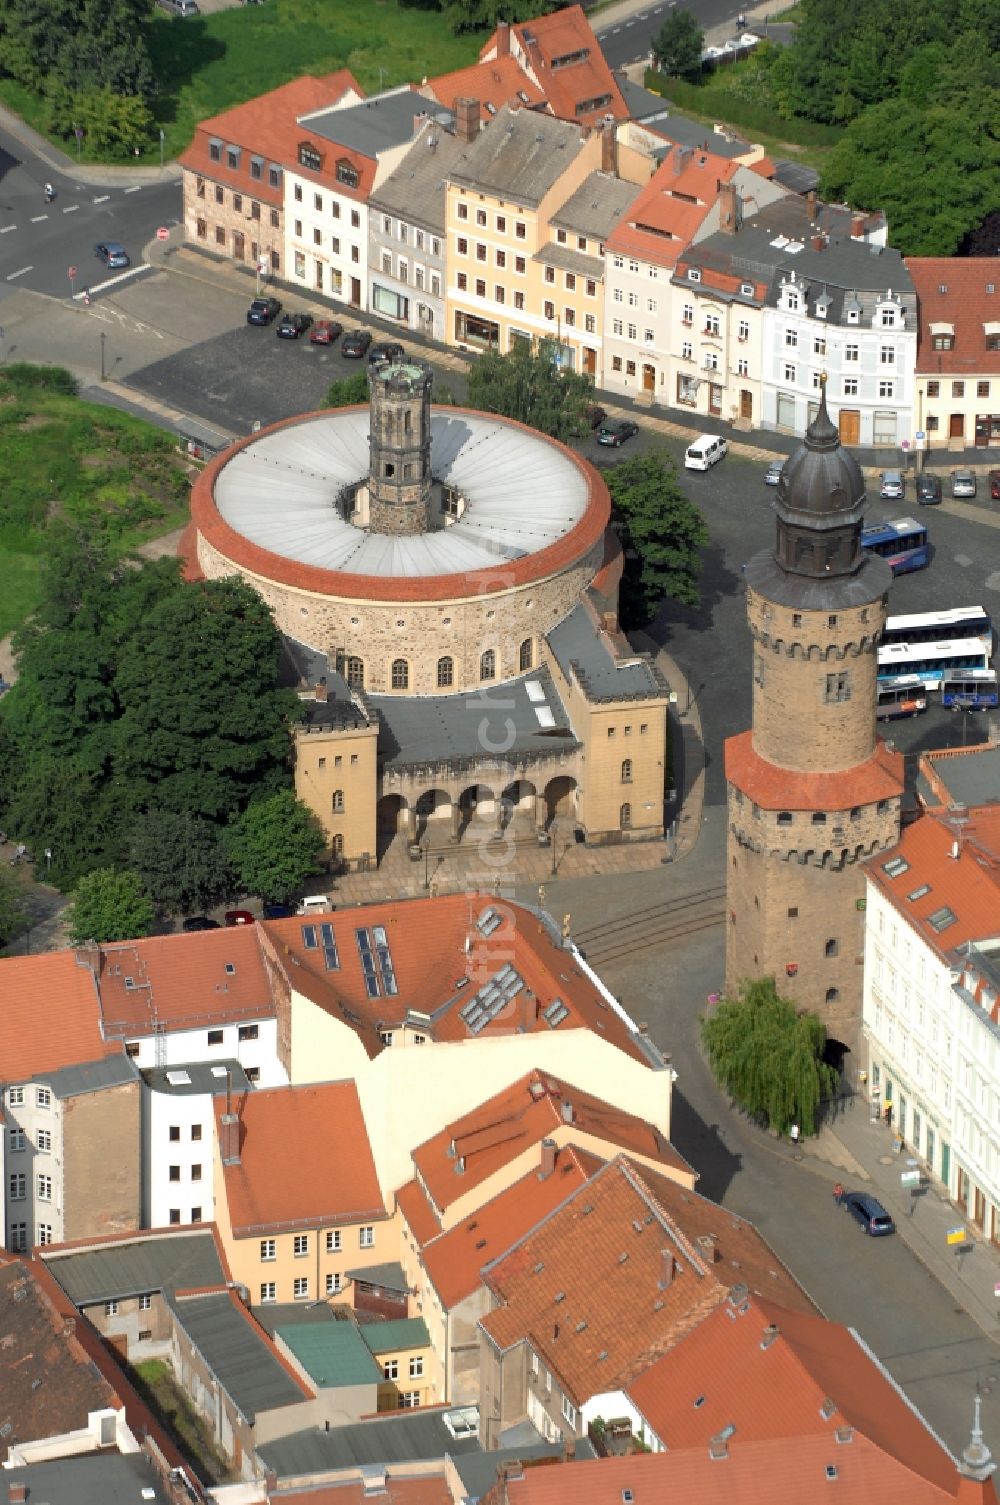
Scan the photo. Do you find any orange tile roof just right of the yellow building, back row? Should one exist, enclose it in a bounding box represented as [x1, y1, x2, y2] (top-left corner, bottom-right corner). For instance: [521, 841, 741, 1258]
[607, 146, 739, 266]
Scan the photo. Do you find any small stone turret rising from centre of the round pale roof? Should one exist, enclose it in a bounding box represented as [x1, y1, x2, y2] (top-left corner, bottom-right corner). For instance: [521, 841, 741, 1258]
[367, 361, 434, 533]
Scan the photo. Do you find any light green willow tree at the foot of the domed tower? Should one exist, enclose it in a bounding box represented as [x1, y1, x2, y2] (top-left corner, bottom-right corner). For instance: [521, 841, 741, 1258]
[702, 977, 837, 1135]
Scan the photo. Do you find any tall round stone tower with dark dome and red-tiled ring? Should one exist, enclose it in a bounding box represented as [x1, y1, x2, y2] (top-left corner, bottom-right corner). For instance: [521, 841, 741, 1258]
[726, 391, 904, 1071]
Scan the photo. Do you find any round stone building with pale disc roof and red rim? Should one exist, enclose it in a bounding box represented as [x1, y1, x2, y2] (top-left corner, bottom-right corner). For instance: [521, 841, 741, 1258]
[191, 363, 610, 695]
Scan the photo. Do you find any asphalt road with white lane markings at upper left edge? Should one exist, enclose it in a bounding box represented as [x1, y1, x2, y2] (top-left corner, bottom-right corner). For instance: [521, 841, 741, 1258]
[0, 131, 181, 310]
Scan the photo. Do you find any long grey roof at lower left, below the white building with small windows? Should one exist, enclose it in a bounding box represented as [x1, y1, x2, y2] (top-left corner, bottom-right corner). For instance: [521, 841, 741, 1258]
[45, 1230, 226, 1306]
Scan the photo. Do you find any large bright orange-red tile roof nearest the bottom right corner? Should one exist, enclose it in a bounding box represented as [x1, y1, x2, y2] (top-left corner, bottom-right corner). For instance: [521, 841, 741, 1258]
[628, 1297, 955, 1490]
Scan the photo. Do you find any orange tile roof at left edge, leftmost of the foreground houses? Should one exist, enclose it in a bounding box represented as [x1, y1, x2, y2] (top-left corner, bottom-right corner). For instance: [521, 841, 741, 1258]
[0, 951, 122, 1082]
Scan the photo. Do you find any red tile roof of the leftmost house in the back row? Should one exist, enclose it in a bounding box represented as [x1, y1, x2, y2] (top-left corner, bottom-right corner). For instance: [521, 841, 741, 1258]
[178, 68, 363, 208]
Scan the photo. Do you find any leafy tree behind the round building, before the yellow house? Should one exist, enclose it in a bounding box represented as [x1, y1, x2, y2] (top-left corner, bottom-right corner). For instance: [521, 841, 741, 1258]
[468, 340, 593, 442]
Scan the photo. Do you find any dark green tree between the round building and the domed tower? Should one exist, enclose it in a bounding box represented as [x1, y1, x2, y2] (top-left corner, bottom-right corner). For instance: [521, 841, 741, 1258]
[605, 450, 708, 628]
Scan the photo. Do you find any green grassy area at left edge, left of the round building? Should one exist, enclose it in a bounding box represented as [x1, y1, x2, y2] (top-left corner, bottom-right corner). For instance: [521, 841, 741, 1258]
[0, 367, 195, 637]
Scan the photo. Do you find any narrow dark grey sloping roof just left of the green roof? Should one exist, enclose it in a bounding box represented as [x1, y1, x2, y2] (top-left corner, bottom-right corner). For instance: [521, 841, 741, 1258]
[173, 1291, 307, 1421]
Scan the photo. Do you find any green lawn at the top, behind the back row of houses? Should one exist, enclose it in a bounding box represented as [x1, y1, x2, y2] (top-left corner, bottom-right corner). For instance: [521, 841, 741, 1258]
[0, 0, 485, 163]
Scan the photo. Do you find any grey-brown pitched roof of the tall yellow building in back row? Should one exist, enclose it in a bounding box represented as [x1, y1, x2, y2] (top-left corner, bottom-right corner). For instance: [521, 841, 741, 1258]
[449, 105, 581, 206]
